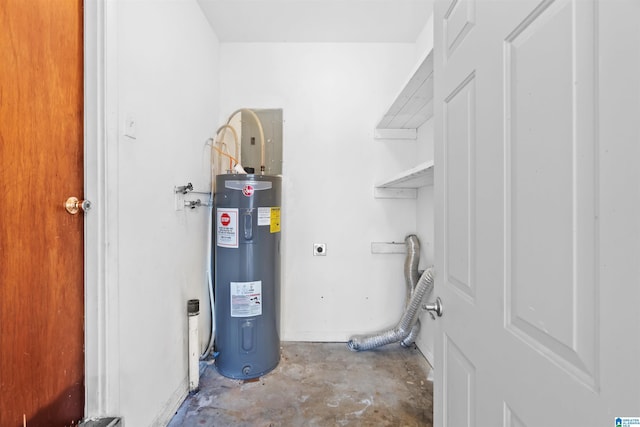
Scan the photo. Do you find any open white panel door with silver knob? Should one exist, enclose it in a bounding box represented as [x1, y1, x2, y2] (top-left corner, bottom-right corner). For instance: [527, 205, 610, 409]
[434, 0, 640, 427]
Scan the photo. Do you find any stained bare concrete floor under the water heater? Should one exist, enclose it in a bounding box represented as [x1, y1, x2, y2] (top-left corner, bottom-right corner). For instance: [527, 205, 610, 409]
[169, 342, 433, 427]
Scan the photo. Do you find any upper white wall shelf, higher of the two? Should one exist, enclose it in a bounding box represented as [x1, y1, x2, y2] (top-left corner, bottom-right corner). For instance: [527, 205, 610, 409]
[376, 51, 433, 132]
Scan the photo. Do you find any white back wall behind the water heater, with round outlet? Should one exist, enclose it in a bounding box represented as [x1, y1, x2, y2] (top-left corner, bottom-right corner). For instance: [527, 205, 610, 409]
[220, 43, 416, 341]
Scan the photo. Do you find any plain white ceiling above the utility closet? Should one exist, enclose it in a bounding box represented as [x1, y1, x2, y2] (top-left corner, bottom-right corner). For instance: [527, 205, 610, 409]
[198, 0, 433, 43]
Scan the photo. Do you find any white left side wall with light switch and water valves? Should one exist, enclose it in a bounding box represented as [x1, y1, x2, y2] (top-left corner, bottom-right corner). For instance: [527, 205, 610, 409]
[108, 0, 219, 426]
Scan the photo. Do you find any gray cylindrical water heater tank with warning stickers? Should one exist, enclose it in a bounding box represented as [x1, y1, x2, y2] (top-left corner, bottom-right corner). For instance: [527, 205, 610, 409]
[214, 174, 282, 379]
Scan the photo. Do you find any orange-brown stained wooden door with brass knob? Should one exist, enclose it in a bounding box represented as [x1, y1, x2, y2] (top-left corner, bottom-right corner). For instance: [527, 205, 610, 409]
[0, 0, 84, 427]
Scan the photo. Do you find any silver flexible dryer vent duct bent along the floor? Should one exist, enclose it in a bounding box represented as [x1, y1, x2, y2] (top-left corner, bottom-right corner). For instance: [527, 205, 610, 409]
[347, 235, 433, 351]
